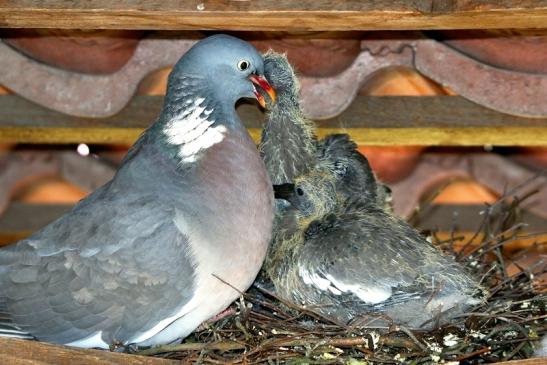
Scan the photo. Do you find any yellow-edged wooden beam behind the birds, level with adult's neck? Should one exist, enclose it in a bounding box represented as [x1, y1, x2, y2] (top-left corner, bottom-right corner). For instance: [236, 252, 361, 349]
[0, 95, 547, 146]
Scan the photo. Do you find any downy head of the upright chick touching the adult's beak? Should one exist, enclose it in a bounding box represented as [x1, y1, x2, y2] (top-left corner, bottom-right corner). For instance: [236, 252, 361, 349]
[264, 51, 300, 109]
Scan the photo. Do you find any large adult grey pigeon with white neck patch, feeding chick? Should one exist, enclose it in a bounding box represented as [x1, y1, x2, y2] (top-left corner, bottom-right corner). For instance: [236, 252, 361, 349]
[0, 35, 274, 348]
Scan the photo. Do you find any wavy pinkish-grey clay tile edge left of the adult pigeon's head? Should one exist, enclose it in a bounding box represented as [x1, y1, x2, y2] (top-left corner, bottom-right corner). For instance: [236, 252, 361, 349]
[0, 39, 195, 118]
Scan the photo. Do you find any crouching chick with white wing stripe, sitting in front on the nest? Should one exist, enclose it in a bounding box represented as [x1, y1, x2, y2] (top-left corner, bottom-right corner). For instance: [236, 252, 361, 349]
[264, 166, 483, 328]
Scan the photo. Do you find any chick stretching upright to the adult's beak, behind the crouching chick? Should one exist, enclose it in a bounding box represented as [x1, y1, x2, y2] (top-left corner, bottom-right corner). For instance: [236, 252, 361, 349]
[259, 51, 391, 209]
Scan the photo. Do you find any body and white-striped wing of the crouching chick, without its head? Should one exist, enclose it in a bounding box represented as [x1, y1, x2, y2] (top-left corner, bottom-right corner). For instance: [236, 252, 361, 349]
[294, 206, 483, 328]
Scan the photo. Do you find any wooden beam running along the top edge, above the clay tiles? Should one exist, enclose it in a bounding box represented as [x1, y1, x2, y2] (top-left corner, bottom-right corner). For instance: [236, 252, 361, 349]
[0, 0, 547, 31]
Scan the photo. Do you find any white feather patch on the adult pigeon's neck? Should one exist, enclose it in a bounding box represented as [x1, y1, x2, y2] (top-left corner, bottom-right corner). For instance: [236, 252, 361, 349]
[163, 97, 227, 163]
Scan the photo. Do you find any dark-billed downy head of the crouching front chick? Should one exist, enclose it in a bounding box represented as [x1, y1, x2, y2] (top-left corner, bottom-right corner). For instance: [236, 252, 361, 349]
[274, 170, 337, 224]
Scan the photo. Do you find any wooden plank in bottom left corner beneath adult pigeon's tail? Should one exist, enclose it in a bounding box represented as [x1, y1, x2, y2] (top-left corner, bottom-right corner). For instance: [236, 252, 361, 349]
[0, 337, 180, 365]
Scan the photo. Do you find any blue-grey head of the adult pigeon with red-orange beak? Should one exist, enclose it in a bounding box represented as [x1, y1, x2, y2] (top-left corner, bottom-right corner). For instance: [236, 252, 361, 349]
[167, 34, 275, 107]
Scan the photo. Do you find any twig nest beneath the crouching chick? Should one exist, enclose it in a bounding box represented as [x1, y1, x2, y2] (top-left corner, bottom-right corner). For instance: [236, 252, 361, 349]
[139, 176, 547, 364]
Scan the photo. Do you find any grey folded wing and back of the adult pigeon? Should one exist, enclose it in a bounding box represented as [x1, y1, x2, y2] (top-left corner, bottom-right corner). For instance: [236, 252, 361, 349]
[0, 141, 195, 347]
